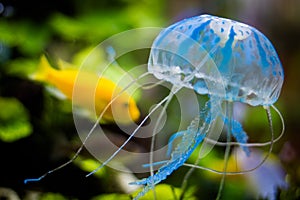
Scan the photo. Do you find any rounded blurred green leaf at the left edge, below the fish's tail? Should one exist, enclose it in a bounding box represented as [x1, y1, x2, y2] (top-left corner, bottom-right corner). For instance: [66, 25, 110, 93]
[0, 98, 32, 142]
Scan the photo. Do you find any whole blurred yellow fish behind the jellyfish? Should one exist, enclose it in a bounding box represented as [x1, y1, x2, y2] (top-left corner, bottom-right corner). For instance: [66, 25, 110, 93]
[31, 55, 140, 124]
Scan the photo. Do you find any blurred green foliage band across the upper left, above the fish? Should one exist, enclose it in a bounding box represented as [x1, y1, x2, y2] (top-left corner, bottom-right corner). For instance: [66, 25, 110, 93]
[0, 0, 164, 59]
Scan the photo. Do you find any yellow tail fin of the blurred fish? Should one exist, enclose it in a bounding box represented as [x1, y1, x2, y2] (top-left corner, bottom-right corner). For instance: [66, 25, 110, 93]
[30, 55, 55, 81]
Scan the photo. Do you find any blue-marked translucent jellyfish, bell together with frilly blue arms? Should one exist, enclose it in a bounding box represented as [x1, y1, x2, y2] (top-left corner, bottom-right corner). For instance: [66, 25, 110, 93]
[131, 15, 284, 199]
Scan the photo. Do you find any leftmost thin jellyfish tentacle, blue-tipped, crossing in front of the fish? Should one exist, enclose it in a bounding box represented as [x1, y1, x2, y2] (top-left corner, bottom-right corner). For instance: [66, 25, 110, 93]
[24, 73, 149, 184]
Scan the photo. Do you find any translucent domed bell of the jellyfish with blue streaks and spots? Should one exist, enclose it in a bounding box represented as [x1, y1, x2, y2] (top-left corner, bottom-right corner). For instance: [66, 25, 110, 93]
[148, 15, 284, 106]
